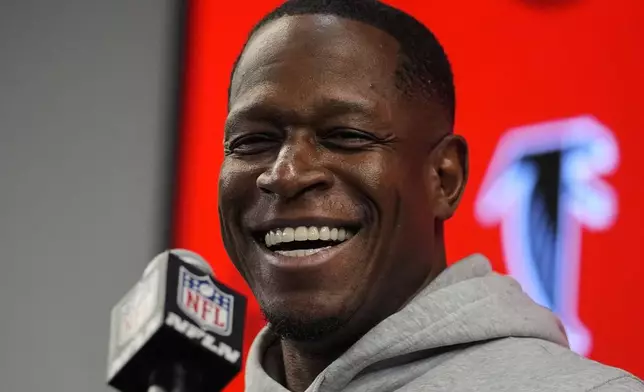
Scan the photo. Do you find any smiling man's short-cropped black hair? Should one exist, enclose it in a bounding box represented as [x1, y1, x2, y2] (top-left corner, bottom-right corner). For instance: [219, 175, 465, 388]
[228, 0, 456, 122]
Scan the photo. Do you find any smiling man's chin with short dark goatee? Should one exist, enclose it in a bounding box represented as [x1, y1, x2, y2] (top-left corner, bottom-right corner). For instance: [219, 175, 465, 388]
[262, 310, 346, 342]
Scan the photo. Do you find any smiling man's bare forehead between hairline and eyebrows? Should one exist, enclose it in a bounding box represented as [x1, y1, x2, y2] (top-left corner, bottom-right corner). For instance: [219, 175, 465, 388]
[231, 15, 398, 102]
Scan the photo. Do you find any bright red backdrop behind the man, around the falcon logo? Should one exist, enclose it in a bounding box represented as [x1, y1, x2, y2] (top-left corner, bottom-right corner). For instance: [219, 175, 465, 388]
[174, 0, 644, 391]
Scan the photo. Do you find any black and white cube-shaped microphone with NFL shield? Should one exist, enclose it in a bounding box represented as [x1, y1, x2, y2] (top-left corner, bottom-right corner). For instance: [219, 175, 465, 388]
[107, 249, 246, 392]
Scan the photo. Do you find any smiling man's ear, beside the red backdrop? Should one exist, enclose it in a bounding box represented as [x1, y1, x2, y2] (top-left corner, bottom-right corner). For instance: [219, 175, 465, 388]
[431, 135, 469, 221]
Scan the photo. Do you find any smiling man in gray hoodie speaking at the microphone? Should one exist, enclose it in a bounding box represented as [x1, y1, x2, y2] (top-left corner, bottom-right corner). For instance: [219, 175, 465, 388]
[219, 0, 644, 392]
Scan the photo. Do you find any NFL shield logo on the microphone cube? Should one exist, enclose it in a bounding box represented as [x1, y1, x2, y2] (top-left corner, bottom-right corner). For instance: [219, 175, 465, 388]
[177, 266, 234, 336]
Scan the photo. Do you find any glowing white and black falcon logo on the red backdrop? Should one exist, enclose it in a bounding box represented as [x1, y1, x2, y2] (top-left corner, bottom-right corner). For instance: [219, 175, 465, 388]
[475, 116, 619, 355]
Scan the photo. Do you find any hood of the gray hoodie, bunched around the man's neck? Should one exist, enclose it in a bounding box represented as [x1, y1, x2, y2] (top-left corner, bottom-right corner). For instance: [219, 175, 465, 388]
[246, 255, 568, 392]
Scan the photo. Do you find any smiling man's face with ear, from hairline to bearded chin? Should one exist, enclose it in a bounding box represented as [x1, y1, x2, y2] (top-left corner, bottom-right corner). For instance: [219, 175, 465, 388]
[219, 15, 465, 340]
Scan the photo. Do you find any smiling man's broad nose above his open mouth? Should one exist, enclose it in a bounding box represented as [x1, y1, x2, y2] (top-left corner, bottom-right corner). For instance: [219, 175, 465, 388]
[257, 139, 333, 199]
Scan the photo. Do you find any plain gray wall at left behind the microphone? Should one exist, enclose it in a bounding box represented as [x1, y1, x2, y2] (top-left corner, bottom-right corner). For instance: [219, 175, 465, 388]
[0, 0, 175, 392]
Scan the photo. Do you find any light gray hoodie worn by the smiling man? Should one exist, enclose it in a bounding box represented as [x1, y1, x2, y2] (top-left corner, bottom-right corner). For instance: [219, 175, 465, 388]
[246, 255, 644, 392]
